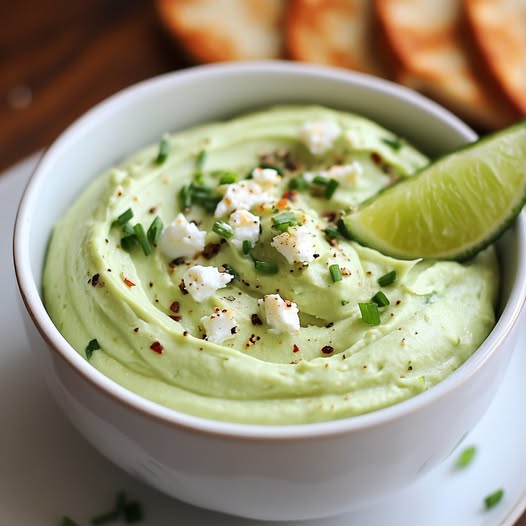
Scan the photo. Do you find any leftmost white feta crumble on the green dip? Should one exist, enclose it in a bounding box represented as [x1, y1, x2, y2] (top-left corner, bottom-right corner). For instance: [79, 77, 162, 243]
[159, 214, 206, 259]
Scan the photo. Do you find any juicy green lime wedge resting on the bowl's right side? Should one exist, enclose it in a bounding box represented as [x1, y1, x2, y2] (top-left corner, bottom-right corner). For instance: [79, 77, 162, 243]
[343, 121, 526, 260]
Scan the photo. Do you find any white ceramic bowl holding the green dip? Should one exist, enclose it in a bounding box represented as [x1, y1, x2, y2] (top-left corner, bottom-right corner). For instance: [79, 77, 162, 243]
[14, 62, 526, 520]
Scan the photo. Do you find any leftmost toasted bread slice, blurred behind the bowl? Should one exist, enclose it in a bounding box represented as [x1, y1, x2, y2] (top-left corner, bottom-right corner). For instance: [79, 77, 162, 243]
[156, 0, 286, 62]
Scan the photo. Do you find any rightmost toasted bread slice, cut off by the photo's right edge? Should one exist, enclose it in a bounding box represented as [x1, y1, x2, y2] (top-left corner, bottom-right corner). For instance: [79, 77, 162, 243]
[464, 0, 526, 116]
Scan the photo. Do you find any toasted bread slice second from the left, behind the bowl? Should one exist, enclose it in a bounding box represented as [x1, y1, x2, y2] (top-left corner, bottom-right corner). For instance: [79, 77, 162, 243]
[285, 0, 384, 76]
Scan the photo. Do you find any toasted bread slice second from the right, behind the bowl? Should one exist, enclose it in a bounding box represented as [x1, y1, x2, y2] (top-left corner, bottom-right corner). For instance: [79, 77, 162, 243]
[375, 0, 518, 130]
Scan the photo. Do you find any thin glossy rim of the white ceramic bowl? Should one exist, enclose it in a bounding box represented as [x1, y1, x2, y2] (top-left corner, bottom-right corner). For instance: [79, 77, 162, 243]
[13, 61, 526, 441]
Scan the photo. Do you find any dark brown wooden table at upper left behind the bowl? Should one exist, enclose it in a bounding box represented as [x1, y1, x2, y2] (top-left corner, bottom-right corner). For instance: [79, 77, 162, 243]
[0, 0, 526, 526]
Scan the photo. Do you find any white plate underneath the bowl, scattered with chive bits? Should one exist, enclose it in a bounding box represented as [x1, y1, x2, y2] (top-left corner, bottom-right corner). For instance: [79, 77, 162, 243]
[0, 156, 526, 526]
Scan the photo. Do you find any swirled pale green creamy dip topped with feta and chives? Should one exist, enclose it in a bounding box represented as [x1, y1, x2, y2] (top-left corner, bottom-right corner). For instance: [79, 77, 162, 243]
[43, 106, 498, 424]
